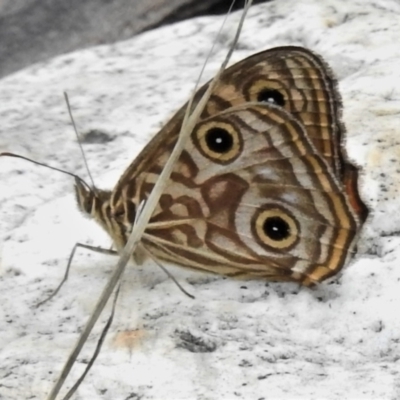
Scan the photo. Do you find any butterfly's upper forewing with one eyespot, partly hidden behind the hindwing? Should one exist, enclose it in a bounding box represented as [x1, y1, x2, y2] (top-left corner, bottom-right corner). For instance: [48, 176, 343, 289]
[111, 46, 368, 222]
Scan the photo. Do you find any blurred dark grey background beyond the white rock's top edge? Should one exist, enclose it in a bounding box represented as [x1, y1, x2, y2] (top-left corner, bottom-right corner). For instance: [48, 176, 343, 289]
[0, 0, 270, 78]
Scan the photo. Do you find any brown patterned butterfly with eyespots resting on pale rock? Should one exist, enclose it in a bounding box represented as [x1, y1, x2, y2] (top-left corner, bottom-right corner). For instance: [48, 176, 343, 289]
[76, 46, 368, 286]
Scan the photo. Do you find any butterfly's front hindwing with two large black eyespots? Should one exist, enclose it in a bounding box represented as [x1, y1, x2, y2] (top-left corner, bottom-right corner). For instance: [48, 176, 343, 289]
[139, 103, 359, 285]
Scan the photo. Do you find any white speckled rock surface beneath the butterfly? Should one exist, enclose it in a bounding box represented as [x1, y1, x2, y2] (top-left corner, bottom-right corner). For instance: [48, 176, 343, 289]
[0, 0, 400, 400]
